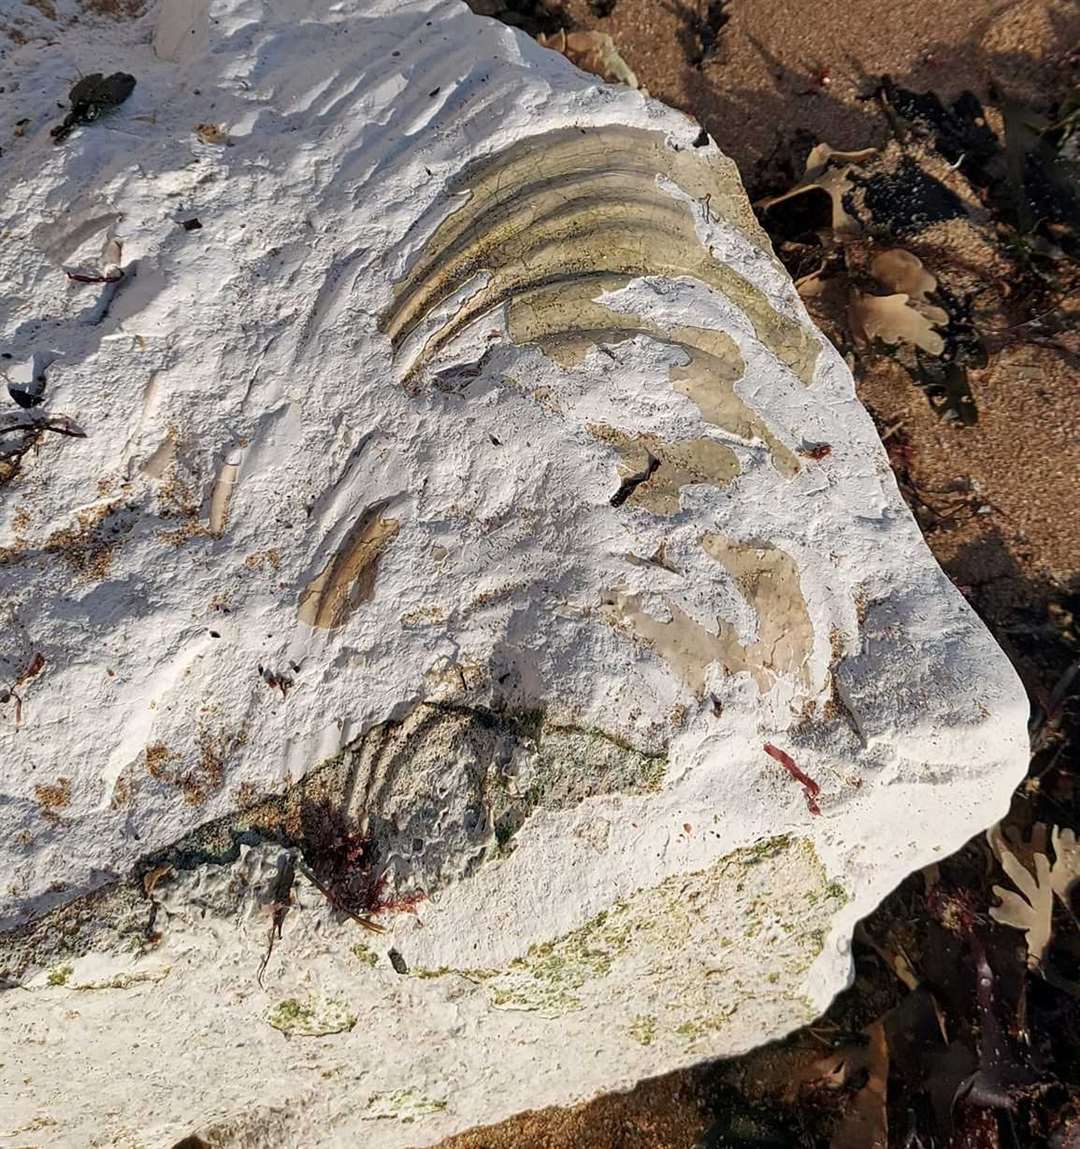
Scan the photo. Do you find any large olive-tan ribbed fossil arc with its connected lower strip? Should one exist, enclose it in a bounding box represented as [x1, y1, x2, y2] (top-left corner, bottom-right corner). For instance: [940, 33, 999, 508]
[380, 128, 804, 473]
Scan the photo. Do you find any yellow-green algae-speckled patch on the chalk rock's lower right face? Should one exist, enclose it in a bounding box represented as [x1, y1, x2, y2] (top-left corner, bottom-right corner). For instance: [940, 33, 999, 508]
[443, 834, 846, 1020]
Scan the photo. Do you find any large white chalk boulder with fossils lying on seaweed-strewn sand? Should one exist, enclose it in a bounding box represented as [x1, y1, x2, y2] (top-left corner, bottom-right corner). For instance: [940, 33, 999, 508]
[0, 0, 1026, 1149]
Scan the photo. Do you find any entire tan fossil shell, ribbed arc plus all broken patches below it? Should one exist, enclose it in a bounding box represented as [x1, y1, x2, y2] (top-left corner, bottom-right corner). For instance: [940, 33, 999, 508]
[380, 126, 819, 693]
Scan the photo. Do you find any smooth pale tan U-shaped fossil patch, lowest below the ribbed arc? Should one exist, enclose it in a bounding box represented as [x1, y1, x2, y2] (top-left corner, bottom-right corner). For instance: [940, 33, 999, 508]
[605, 534, 813, 695]
